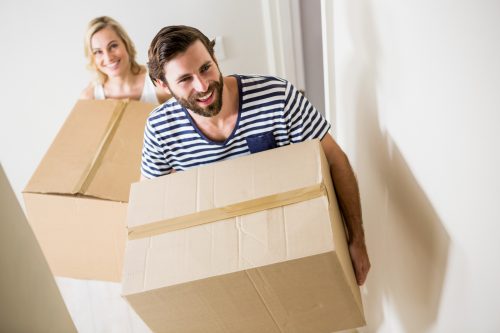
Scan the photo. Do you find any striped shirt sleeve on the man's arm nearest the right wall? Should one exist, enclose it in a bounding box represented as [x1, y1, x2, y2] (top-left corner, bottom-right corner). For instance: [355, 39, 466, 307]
[284, 82, 331, 143]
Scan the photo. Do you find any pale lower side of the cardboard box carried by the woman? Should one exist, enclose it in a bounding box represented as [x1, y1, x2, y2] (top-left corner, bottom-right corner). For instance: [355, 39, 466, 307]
[23, 193, 127, 281]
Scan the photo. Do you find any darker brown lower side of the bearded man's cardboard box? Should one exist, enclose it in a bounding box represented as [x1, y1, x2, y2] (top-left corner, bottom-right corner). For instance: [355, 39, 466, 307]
[126, 252, 365, 333]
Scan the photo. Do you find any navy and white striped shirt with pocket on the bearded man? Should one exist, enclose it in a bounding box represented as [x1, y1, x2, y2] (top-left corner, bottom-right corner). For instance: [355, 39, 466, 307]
[141, 75, 330, 178]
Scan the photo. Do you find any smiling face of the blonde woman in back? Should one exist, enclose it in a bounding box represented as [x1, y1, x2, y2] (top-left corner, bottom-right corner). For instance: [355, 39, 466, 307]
[90, 27, 130, 77]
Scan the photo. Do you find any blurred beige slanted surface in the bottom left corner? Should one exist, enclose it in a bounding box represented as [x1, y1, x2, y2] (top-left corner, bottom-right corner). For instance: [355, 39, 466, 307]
[0, 165, 76, 333]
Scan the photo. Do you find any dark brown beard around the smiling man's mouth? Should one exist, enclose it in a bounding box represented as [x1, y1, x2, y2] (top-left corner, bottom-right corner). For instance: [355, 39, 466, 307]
[174, 73, 224, 117]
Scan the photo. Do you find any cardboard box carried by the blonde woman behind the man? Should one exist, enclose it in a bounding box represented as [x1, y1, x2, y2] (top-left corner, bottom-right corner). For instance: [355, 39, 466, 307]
[23, 100, 154, 281]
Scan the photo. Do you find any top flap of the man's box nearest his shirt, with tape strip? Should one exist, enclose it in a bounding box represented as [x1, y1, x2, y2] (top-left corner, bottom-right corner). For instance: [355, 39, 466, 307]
[127, 140, 328, 239]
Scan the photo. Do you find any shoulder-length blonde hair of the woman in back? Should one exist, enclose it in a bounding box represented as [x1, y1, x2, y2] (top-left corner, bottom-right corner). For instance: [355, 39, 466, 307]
[85, 16, 141, 83]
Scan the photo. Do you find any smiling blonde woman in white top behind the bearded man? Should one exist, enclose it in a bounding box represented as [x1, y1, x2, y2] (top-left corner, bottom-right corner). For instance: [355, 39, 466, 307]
[80, 16, 170, 104]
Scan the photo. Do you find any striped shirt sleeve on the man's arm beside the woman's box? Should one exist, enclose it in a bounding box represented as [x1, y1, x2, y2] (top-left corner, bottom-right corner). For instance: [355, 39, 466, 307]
[141, 119, 172, 178]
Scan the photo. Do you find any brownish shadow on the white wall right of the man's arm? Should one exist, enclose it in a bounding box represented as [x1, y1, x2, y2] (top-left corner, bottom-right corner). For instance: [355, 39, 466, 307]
[357, 114, 450, 333]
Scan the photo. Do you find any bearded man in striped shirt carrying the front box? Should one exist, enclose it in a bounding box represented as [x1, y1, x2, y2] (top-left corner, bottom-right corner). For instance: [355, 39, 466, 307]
[142, 26, 370, 285]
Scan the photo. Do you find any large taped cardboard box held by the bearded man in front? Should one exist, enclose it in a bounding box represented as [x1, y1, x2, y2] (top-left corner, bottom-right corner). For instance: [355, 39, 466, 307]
[122, 140, 365, 333]
